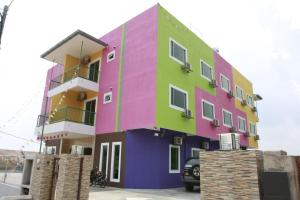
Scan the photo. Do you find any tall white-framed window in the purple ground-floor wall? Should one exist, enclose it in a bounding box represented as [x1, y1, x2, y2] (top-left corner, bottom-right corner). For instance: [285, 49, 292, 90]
[169, 144, 180, 173]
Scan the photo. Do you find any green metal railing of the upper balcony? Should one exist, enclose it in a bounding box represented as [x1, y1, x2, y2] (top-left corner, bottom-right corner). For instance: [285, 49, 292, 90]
[49, 65, 99, 90]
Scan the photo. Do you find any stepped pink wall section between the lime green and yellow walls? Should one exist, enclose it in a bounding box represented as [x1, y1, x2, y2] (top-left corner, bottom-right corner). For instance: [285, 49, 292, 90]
[195, 53, 248, 145]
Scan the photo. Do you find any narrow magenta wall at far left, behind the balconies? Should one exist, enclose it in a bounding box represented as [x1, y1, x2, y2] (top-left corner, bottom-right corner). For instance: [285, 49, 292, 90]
[41, 64, 63, 114]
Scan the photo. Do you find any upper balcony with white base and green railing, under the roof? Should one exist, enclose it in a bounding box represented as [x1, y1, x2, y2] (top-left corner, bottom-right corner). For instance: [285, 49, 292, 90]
[48, 65, 99, 97]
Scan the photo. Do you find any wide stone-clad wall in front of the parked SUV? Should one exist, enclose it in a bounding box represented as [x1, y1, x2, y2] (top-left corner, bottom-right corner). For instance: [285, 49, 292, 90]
[200, 151, 260, 200]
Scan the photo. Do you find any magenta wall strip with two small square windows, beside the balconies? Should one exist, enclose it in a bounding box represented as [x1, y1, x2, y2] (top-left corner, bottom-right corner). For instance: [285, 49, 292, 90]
[96, 26, 122, 134]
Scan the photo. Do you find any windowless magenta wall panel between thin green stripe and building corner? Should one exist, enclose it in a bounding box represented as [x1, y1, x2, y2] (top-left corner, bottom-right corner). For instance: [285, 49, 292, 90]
[120, 6, 157, 130]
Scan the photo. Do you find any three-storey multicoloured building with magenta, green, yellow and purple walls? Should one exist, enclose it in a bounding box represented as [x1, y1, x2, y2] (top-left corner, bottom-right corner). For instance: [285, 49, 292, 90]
[36, 4, 261, 188]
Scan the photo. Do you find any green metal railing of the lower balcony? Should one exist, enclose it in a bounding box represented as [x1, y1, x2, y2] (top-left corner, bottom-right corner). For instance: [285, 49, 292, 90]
[37, 107, 96, 127]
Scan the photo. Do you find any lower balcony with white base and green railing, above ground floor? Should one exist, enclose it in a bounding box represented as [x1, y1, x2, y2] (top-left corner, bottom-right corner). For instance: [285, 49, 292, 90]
[35, 107, 96, 138]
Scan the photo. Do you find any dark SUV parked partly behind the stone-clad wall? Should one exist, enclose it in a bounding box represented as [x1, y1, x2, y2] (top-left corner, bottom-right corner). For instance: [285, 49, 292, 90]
[182, 158, 200, 191]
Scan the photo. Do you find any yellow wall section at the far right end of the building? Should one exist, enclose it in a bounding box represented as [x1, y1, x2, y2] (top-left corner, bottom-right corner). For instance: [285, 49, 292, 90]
[232, 68, 258, 148]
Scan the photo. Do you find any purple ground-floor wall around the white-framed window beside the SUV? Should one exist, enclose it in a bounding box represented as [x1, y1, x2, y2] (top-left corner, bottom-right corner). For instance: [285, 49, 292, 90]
[124, 129, 200, 189]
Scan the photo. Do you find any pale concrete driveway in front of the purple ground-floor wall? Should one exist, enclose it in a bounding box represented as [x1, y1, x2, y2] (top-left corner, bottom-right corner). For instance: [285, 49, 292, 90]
[89, 187, 200, 200]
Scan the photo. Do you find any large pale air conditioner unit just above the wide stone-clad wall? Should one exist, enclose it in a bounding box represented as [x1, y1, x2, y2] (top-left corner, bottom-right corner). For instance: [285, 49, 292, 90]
[219, 133, 240, 150]
